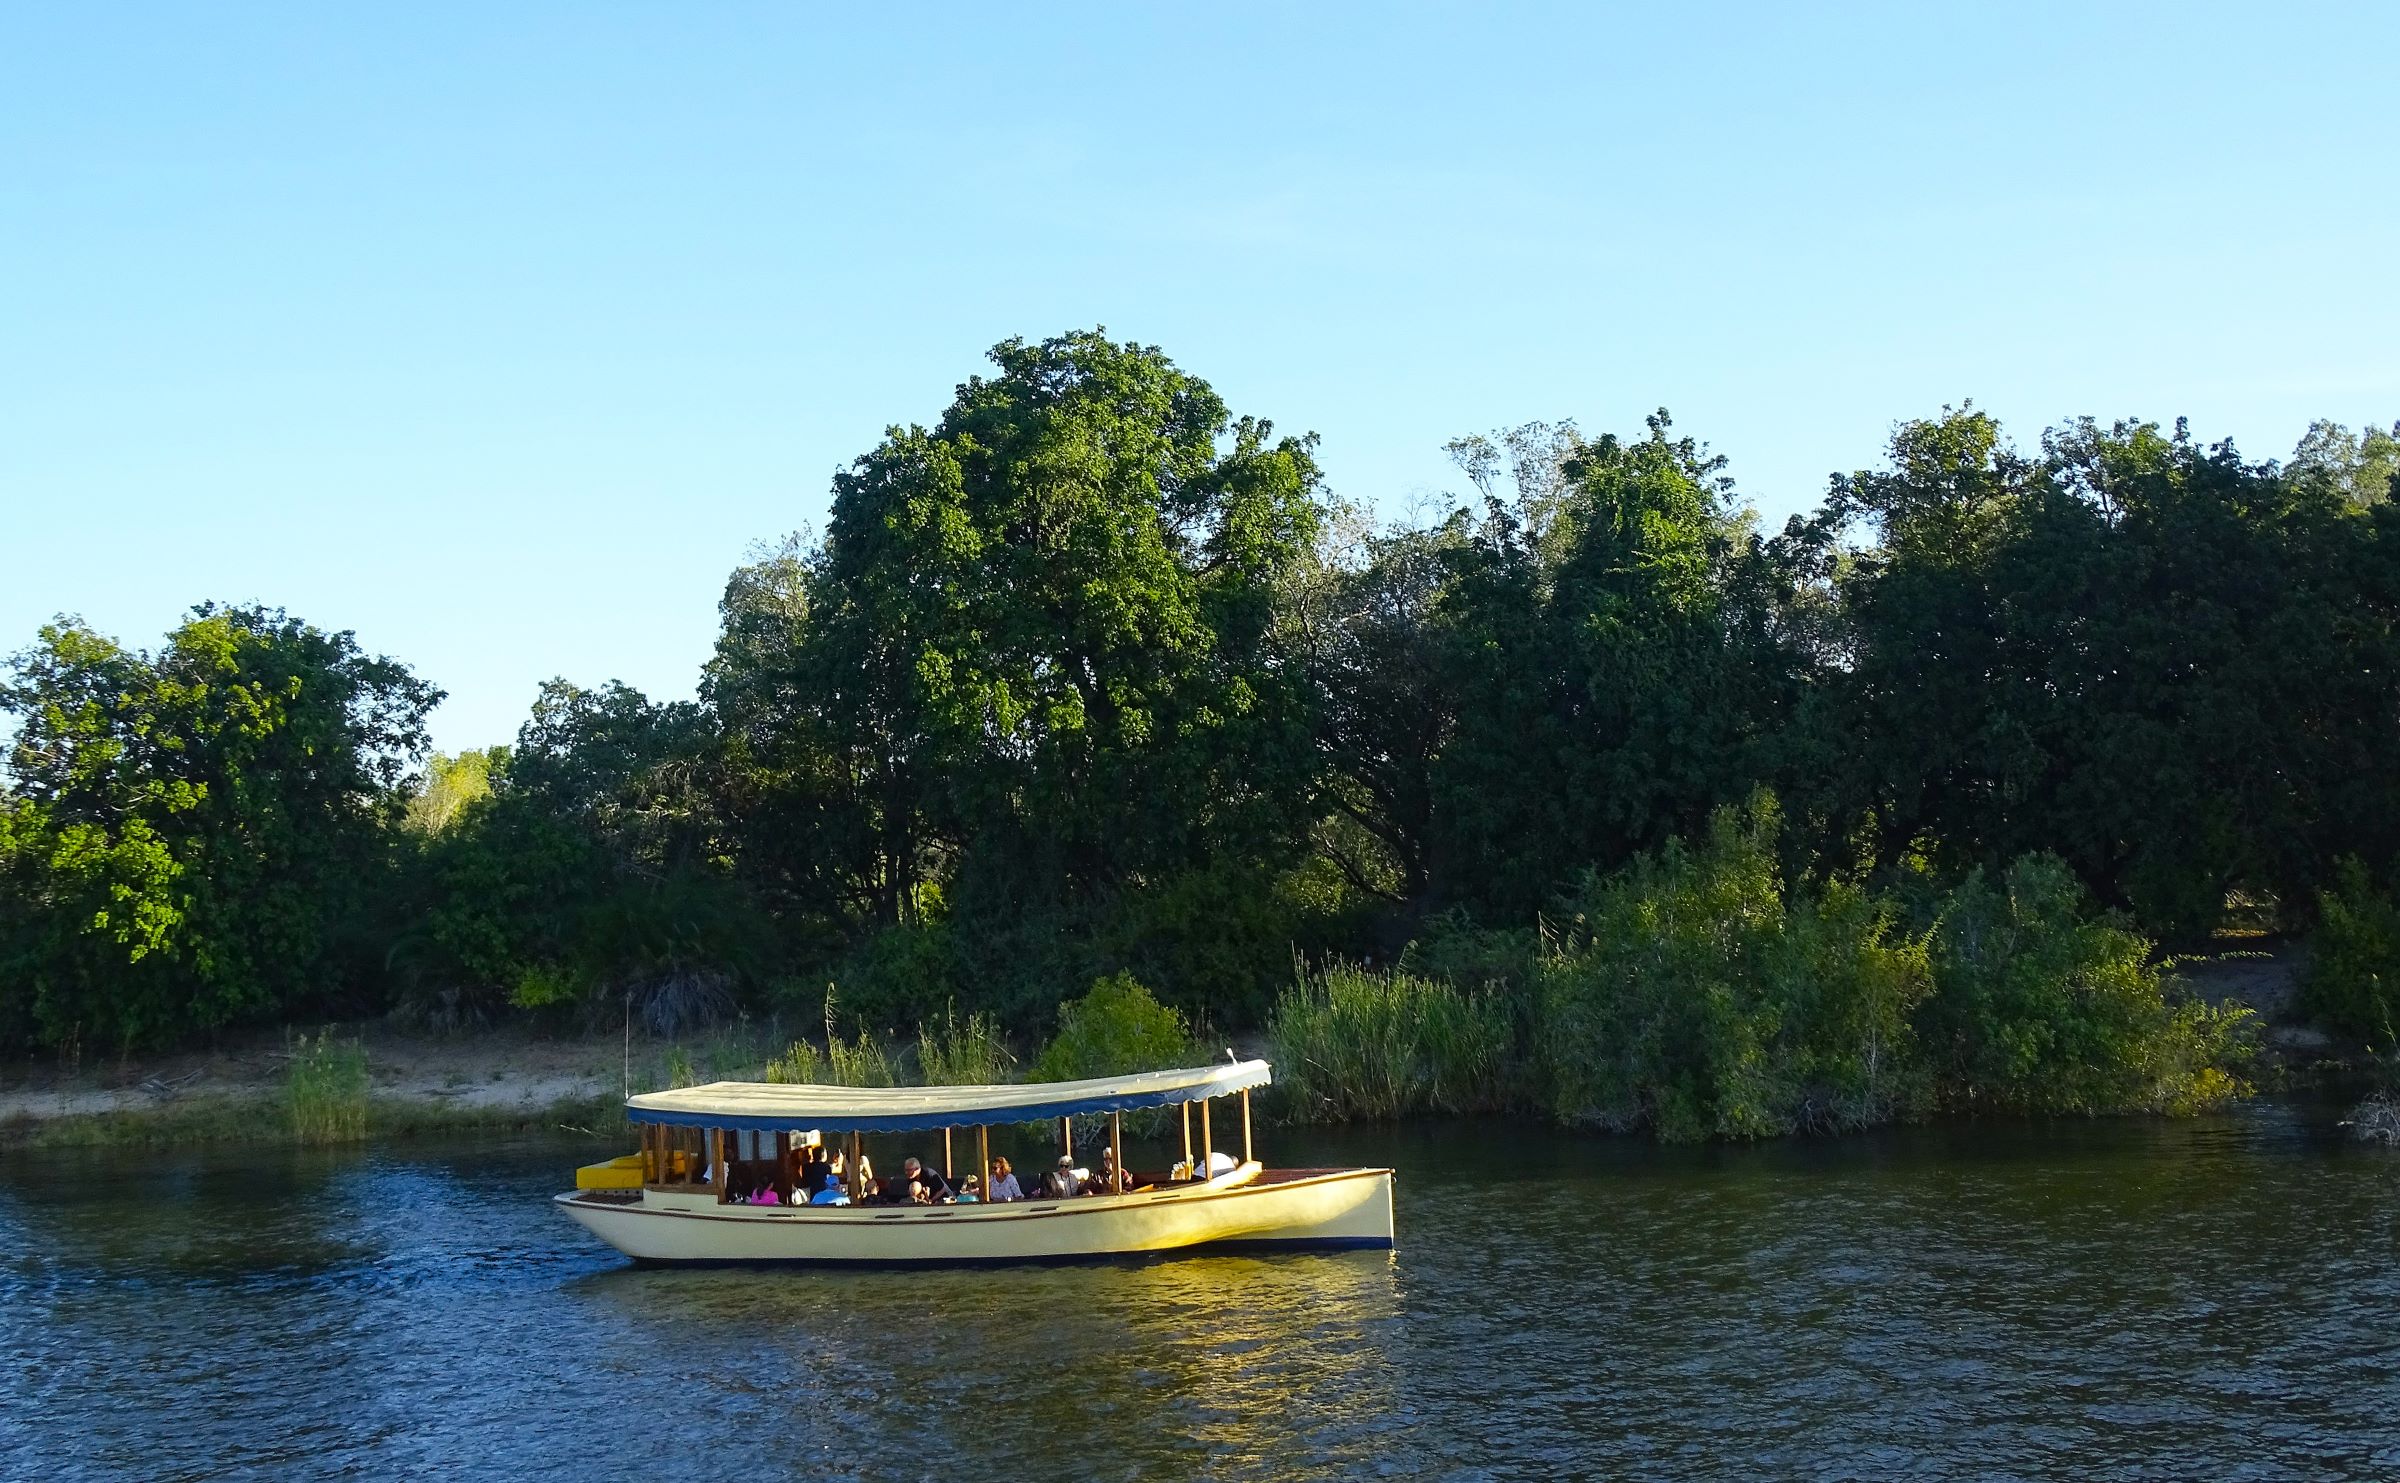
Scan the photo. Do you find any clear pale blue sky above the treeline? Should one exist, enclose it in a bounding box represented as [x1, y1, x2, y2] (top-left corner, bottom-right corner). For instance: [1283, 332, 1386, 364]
[0, 2, 2400, 749]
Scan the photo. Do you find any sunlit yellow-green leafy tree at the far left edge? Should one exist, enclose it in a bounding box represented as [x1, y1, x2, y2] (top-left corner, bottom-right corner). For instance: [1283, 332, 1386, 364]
[0, 605, 442, 1049]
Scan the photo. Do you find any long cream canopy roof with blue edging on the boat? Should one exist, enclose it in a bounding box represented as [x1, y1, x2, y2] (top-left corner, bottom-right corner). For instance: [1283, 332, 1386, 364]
[624, 1061, 1274, 1133]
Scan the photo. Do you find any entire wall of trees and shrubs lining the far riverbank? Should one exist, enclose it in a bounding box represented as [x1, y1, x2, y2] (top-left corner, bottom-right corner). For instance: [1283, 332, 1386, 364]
[0, 329, 2400, 1142]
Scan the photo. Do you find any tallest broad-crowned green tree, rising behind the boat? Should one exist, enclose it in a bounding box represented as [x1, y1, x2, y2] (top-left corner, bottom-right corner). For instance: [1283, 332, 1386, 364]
[706, 331, 1320, 1022]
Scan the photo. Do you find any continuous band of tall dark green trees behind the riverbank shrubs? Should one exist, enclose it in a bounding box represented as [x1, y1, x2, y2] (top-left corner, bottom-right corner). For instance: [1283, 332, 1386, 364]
[0, 329, 2400, 1060]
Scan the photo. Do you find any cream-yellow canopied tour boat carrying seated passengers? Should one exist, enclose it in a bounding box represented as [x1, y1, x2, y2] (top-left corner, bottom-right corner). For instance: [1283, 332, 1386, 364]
[557, 1061, 1392, 1265]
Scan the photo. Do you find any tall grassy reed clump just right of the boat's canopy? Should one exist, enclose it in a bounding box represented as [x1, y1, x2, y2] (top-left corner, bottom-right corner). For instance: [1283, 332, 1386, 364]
[1267, 962, 1512, 1121]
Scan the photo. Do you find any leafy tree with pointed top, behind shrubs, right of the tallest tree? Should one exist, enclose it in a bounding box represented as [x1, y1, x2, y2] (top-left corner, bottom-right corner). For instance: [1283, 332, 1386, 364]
[1435, 413, 1812, 921]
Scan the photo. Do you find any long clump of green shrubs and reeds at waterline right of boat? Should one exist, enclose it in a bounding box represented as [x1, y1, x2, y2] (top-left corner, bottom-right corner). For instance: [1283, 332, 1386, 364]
[1272, 794, 2246, 1140]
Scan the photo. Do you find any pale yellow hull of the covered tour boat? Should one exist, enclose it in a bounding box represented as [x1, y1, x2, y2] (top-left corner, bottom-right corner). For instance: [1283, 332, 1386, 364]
[557, 1164, 1392, 1265]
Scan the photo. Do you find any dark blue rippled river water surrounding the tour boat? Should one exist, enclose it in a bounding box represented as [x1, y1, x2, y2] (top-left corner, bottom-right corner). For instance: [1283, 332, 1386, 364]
[0, 1106, 2400, 1481]
